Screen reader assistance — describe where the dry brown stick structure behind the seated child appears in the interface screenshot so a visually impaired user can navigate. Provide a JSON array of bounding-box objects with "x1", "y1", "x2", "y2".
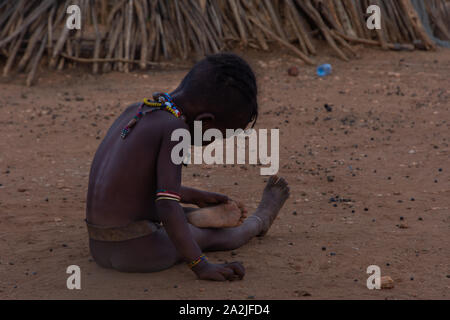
[{"x1": 0, "y1": 0, "x2": 450, "y2": 85}]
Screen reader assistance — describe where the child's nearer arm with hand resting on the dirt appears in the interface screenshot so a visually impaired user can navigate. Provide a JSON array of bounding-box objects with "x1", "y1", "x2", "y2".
[{"x1": 156, "y1": 121, "x2": 245, "y2": 281}]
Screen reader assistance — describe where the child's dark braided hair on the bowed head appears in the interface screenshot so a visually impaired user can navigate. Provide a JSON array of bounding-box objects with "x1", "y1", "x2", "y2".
[{"x1": 180, "y1": 53, "x2": 258, "y2": 126}]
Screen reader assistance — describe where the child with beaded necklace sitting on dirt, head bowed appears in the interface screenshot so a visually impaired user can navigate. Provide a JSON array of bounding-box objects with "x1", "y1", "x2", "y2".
[{"x1": 86, "y1": 53, "x2": 289, "y2": 281}]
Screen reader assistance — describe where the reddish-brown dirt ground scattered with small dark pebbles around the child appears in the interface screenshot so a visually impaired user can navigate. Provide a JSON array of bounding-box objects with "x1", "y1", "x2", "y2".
[{"x1": 0, "y1": 48, "x2": 450, "y2": 299}]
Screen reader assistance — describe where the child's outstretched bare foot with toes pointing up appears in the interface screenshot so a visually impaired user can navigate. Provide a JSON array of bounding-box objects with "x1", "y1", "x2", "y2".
[{"x1": 249, "y1": 176, "x2": 289, "y2": 237}]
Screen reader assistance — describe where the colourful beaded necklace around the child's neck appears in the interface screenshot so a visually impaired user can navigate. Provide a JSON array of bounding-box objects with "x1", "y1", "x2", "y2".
[{"x1": 120, "y1": 93, "x2": 184, "y2": 139}]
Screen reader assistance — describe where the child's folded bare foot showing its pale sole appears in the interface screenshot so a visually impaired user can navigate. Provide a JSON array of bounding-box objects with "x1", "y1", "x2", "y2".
[{"x1": 187, "y1": 201, "x2": 247, "y2": 228}]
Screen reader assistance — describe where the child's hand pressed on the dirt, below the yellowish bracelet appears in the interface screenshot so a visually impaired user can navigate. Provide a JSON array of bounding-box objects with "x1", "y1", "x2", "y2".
[{"x1": 192, "y1": 261, "x2": 245, "y2": 281}]
